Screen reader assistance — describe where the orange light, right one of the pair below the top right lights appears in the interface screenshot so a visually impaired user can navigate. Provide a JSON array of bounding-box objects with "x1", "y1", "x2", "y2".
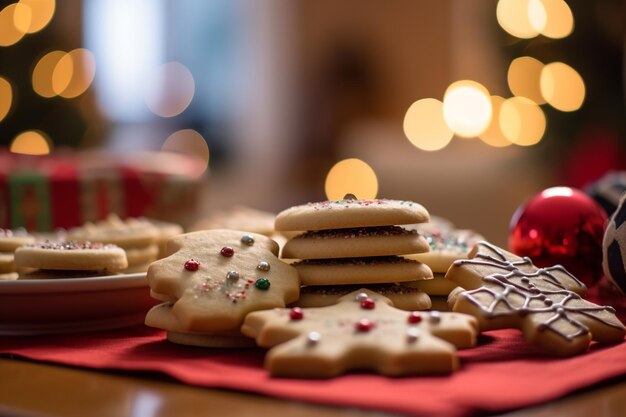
[{"x1": 540, "y1": 62, "x2": 585, "y2": 111}]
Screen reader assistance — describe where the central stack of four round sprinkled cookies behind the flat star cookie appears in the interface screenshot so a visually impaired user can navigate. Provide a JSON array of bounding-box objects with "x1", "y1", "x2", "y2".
[{"x1": 275, "y1": 195, "x2": 433, "y2": 310}]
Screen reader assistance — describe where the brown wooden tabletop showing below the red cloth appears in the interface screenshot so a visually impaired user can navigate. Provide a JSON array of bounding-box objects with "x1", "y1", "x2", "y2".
[{"x1": 0, "y1": 358, "x2": 626, "y2": 417}]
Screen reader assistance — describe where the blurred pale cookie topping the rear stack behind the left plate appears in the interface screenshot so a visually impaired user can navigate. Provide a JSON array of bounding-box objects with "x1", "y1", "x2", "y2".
[{"x1": 67, "y1": 214, "x2": 159, "y2": 249}]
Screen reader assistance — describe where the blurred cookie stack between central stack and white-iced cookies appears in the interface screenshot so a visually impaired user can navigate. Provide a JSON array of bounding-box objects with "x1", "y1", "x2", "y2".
[{"x1": 407, "y1": 218, "x2": 484, "y2": 311}]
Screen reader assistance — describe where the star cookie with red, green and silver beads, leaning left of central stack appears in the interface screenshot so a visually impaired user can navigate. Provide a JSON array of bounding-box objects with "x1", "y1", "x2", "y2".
[{"x1": 148, "y1": 229, "x2": 300, "y2": 342}]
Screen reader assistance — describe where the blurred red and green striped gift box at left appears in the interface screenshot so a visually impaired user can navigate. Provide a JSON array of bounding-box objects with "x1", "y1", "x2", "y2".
[{"x1": 0, "y1": 150, "x2": 202, "y2": 231}]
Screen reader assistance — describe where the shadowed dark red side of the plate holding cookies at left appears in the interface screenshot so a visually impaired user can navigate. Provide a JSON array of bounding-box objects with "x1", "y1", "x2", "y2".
[{"x1": 0, "y1": 273, "x2": 159, "y2": 336}]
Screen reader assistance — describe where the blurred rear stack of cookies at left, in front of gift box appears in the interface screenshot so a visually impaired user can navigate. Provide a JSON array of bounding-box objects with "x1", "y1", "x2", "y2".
[{"x1": 67, "y1": 214, "x2": 183, "y2": 273}]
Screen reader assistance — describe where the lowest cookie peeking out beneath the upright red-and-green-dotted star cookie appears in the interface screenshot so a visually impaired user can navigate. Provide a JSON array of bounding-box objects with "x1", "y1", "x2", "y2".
[{"x1": 146, "y1": 302, "x2": 256, "y2": 348}]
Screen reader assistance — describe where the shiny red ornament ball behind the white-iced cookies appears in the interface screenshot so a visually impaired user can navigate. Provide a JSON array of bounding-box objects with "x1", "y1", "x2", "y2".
[{"x1": 509, "y1": 187, "x2": 607, "y2": 287}]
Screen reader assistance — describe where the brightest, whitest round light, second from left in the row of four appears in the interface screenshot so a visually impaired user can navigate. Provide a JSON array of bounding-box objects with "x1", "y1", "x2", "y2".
[{"x1": 443, "y1": 80, "x2": 492, "y2": 137}]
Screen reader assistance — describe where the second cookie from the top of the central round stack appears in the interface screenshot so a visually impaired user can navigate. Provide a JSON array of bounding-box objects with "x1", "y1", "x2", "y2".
[{"x1": 282, "y1": 226, "x2": 429, "y2": 259}]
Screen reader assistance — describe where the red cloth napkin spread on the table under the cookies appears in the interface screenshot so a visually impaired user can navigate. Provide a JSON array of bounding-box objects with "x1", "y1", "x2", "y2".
[{"x1": 0, "y1": 320, "x2": 626, "y2": 416}]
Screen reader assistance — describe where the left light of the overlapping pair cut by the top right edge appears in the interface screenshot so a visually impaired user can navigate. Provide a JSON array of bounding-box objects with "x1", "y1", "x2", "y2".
[{"x1": 496, "y1": 0, "x2": 545, "y2": 39}]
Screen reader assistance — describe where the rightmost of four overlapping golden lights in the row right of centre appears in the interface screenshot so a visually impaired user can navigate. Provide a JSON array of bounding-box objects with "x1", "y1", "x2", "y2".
[{"x1": 499, "y1": 97, "x2": 546, "y2": 146}]
